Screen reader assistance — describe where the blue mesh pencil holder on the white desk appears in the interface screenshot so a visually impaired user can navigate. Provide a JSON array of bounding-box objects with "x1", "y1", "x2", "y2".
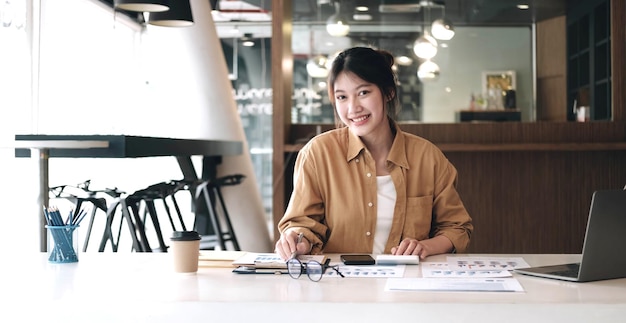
[{"x1": 46, "y1": 225, "x2": 79, "y2": 263}]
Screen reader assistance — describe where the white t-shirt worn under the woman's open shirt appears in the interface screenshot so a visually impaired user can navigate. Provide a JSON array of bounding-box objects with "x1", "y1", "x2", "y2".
[{"x1": 373, "y1": 175, "x2": 396, "y2": 255}]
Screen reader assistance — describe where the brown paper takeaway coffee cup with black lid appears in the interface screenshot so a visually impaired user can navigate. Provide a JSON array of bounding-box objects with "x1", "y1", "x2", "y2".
[{"x1": 170, "y1": 231, "x2": 200, "y2": 273}]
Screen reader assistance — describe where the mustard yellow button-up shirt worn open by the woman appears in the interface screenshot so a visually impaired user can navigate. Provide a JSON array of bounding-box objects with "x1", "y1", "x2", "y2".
[{"x1": 278, "y1": 125, "x2": 473, "y2": 254}]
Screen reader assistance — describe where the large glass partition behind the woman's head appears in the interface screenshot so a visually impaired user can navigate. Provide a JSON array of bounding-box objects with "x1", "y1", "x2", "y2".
[{"x1": 292, "y1": 25, "x2": 534, "y2": 123}]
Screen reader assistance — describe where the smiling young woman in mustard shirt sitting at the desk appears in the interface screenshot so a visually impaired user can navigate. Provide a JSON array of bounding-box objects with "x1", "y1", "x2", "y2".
[{"x1": 275, "y1": 47, "x2": 473, "y2": 259}]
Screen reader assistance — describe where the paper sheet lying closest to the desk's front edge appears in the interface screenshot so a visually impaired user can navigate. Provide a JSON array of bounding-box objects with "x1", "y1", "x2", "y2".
[{"x1": 385, "y1": 278, "x2": 524, "y2": 292}]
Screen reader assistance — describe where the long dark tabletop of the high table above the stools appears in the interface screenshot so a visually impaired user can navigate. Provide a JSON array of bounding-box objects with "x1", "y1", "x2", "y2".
[{"x1": 15, "y1": 135, "x2": 243, "y2": 158}]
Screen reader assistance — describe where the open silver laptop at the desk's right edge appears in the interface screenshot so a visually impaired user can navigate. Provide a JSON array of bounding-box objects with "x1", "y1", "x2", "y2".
[{"x1": 514, "y1": 190, "x2": 626, "y2": 282}]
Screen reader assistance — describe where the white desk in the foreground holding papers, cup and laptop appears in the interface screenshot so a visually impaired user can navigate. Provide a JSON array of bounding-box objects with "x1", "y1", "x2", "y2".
[{"x1": 0, "y1": 253, "x2": 626, "y2": 323}]
